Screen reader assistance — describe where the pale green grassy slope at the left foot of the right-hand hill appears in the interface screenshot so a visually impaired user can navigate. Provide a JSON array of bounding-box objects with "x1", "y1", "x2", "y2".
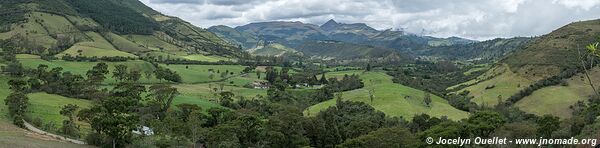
[{"x1": 458, "y1": 65, "x2": 534, "y2": 106}]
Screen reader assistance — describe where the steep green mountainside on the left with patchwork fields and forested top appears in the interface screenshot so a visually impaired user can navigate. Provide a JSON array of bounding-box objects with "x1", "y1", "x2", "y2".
[{"x1": 0, "y1": 0, "x2": 242, "y2": 57}]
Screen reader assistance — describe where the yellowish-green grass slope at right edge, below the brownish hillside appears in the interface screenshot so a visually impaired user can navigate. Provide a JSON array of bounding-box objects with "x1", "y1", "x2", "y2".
[{"x1": 516, "y1": 67, "x2": 600, "y2": 118}]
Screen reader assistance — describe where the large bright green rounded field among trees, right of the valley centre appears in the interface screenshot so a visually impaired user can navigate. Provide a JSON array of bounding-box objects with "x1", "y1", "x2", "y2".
[{"x1": 304, "y1": 71, "x2": 468, "y2": 120}]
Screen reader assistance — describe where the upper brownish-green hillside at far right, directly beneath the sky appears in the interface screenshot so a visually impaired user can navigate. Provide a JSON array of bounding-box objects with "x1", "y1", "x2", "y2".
[{"x1": 501, "y1": 20, "x2": 600, "y2": 78}]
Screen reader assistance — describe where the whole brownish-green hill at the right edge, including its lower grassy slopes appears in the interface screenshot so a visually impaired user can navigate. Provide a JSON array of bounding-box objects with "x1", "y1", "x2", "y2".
[{"x1": 452, "y1": 20, "x2": 600, "y2": 118}]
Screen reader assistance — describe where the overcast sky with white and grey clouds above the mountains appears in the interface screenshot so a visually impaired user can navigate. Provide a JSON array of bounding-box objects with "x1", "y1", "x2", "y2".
[{"x1": 141, "y1": 0, "x2": 600, "y2": 40}]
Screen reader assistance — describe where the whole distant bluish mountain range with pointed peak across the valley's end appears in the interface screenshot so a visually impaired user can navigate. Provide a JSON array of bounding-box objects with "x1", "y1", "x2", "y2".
[{"x1": 208, "y1": 19, "x2": 529, "y2": 60}]
